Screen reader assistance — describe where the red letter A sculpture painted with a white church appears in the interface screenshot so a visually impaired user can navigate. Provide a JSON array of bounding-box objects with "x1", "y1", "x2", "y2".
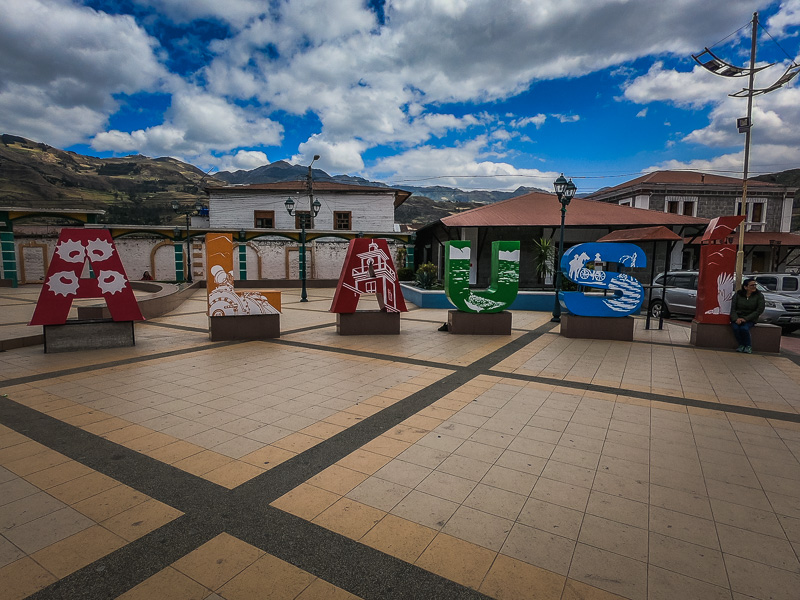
[{"x1": 331, "y1": 238, "x2": 408, "y2": 313}]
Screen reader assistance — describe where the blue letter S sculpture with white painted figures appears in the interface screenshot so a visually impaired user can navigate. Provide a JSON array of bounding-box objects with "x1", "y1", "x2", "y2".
[{"x1": 559, "y1": 242, "x2": 647, "y2": 317}]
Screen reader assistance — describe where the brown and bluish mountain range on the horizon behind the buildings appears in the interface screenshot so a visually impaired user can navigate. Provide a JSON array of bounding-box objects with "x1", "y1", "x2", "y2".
[{"x1": 0, "y1": 134, "x2": 800, "y2": 228}]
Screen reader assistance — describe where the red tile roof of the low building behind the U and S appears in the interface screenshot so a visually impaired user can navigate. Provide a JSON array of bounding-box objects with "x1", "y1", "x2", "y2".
[{"x1": 442, "y1": 192, "x2": 708, "y2": 227}]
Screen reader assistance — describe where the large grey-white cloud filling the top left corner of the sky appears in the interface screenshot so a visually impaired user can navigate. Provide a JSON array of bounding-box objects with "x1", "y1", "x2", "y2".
[{"x1": 0, "y1": 0, "x2": 171, "y2": 145}]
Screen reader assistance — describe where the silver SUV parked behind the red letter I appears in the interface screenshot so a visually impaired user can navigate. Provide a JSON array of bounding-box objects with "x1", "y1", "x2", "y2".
[{"x1": 648, "y1": 271, "x2": 800, "y2": 333}]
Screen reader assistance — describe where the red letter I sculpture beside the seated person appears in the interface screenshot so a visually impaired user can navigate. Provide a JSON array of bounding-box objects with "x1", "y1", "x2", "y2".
[{"x1": 695, "y1": 216, "x2": 744, "y2": 325}]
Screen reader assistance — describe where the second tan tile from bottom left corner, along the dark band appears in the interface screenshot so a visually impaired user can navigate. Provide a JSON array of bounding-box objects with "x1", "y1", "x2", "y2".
[{"x1": 31, "y1": 525, "x2": 127, "y2": 577}]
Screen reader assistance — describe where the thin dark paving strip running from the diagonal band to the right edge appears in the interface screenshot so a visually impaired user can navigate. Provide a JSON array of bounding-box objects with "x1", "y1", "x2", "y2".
[{"x1": 487, "y1": 371, "x2": 800, "y2": 423}]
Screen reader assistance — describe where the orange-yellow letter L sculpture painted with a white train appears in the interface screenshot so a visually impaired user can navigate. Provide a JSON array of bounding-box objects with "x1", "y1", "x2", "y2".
[{"x1": 206, "y1": 233, "x2": 281, "y2": 317}]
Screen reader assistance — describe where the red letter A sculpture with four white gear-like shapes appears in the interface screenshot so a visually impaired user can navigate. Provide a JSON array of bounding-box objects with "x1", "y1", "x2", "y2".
[{"x1": 29, "y1": 229, "x2": 144, "y2": 325}]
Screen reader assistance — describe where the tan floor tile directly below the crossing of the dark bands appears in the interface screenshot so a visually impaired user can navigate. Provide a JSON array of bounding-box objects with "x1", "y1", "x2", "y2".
[{"x1": 172, "y1": 533, "x2": 264, "y2": 590}]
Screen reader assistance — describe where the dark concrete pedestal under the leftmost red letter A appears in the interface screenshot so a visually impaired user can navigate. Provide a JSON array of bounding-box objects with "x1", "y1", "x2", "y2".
[{"x1": 42, "y1": 319, "x2": 136, "y2": 353}]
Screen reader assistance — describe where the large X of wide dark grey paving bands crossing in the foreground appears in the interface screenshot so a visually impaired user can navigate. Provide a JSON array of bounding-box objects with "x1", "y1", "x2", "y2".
[{"x1": 0, "y1": 326, "x2": 552, "y2": 600}]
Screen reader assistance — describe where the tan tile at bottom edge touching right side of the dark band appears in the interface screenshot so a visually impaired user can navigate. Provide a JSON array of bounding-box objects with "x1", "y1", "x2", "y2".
[{"x1": 480, "y1": 554, "x2": 565, "y2": 600}]
